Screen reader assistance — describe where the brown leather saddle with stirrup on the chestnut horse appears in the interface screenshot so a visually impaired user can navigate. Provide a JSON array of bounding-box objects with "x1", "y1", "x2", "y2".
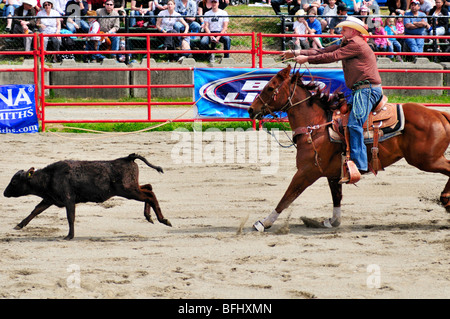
[{"x1": 328, "y1": 95, "x2": 405, "y2": 184}]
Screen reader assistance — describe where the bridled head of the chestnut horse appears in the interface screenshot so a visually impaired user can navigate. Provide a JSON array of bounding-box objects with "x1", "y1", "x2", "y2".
[{"x1": 248, "y1": 65, "x2": 291, "y2": 119}]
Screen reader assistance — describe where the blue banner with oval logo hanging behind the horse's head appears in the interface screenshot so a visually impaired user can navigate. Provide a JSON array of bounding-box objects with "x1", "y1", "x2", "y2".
[{"x1": 194, "y1": 68, "x2": 351, "y2": 118}]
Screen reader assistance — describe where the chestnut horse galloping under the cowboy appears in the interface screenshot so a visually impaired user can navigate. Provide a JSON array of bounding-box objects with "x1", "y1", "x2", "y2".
[{"x1": 248, "y1": 65, "x2": 450, "y2": 231}]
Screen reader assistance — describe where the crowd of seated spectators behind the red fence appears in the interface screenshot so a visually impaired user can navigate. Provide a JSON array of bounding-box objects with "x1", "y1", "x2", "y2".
[{"x1": 0, "y1": 0, "x2": 450, "y2": 63}]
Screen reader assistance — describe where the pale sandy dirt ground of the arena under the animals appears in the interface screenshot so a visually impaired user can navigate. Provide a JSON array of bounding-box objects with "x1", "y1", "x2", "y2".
[{"x1": 0, "y1": 125, "x2": 450, "y2": 299}]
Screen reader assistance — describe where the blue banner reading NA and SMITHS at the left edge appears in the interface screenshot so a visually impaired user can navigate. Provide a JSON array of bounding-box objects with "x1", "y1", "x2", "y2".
[{"x1": 0, "y1": 84, "x2": 39, "y2": 133}]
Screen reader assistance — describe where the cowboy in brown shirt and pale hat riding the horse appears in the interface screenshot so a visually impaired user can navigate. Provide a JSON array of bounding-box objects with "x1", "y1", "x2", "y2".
[{"x1": 281, "y1": 16, "x2": 383, "y2": 183}]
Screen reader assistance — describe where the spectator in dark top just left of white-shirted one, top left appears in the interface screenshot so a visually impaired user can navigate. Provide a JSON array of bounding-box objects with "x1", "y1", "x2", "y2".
[{"x1": 11, "y1": 0, "x2": 37, "y2": 51}]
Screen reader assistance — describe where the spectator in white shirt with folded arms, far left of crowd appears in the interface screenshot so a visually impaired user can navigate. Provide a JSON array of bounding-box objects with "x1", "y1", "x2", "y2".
[{"x1": 36, "y1": 0, "x2": 61, "y2": 63}]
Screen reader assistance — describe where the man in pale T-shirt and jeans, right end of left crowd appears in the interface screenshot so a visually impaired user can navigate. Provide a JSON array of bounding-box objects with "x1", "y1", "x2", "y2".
[{"x1": 200, "y1": 0, "x2": 229, "y2": 63}]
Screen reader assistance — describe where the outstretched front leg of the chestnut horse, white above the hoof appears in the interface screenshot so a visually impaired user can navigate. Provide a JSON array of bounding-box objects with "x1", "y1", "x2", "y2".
[{"x1": 253, "y1": 170, "x2": 320, "y2": 232}]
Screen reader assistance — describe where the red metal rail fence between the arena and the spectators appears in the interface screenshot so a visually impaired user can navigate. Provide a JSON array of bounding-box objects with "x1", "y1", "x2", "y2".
[{"x1": 0, "y1": 33, "x2": 450, "y2": 131}]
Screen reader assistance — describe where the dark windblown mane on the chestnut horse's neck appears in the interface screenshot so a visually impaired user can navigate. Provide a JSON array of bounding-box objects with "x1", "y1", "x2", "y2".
[{"x1": 292, "y1": 71, "x2": 344, "y2": 111}]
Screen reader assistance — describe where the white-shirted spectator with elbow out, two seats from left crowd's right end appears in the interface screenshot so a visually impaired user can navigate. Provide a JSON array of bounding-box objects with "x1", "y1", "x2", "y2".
[{"x1": 156, "y1": 0, "x2": 191, "y2": 62}]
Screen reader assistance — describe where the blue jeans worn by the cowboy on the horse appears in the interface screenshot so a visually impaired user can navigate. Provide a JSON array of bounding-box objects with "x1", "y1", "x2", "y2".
[{"x1": 348, "y1": 87, "x2": 383, "y2": 171}]
